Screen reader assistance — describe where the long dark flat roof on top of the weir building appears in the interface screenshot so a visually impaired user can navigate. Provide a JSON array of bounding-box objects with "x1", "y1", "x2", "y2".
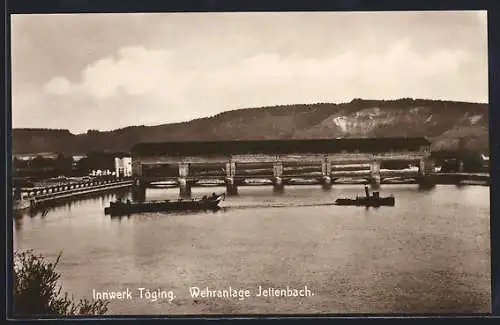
[{"x1": 131, "y1": 138, "x2": 430, "y2": 156}]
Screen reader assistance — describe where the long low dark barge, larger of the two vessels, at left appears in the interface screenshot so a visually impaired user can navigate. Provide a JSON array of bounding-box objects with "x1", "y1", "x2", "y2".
[{"x1": 104, "y1": 193, "x2": 226, "y2": 216}]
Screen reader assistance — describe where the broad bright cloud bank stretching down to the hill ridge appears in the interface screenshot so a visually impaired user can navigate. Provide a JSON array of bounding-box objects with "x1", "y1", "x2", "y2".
[{"x1": 27, "y1": 39, "x2": 488, "y2": 130}]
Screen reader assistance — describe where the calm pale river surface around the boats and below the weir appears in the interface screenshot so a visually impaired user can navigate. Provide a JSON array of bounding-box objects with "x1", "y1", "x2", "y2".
[{"x1": 14, "y1": 185, "x2": 491, "y2": 315}]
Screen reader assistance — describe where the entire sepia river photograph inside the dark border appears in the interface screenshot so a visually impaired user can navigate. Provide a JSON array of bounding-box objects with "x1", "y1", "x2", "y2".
[{"x1": 10, "y1": 11, "x2": 491, "y2": 317}]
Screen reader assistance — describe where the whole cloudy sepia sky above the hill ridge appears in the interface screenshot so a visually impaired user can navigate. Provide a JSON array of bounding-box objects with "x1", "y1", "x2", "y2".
[{"x1": 11, "y1": 11, "x2": 488, "y2": 134}]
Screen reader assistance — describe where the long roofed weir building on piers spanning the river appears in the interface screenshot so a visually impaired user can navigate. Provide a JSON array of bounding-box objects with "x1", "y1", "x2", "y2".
[{"x1": 131, "y1": 137, "x2": 434, "y2": 196}]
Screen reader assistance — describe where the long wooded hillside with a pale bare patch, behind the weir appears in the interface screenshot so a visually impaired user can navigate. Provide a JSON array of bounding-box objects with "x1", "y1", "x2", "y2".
[{"x1": 12, "y1": 99, "x2": 488, "y2": 155}]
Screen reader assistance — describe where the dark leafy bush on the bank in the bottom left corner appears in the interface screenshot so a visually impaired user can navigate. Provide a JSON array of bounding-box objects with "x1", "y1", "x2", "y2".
[{"x1": 13, "y1": 250, "x2": 109, "y2": 317}]
